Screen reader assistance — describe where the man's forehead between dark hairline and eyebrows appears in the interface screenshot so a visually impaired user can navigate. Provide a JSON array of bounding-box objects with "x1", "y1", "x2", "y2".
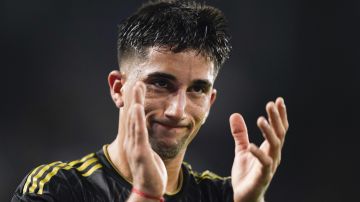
[{"x1": 135, "y1": 48, "x2": 215, "y2": 83}]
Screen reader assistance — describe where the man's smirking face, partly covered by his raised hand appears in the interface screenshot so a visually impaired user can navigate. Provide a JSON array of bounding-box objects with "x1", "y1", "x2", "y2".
[{"x1": 123, "y1": 48, "x2": 216, "y2": 159}]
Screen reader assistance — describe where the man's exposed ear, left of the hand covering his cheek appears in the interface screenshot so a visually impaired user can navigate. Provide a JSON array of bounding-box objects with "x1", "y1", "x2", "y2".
[{"x1": 108, "y1": 70, "x2": 125, "y2": 108}]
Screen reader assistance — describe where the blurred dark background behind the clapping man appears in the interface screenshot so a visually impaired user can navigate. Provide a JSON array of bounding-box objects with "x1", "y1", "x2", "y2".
[{"x1": 0, "y1": 0, "x2": 360, "y2": 202}]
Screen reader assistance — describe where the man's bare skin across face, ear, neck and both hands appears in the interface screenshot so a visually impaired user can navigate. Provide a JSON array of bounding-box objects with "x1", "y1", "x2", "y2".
[{"x1": 108, "y1": 48, "x2": 288, "y2": 202}]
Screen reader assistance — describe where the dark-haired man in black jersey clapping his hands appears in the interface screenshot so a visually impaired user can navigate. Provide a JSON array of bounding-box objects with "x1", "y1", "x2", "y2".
[{"x1": 12, "y1": 0, "x2": 288, "y2": 202}]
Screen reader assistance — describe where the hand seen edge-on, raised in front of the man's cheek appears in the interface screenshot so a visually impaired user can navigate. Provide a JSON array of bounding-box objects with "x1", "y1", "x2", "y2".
[{"x1": 122, "y1": 82, "x2": 167, "y2": 197}]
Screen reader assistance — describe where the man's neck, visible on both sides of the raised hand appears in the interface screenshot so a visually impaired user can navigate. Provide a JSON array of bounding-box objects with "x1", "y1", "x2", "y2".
[{"x1": 108, "y1": 131, "x2": 185, "y2": 195}]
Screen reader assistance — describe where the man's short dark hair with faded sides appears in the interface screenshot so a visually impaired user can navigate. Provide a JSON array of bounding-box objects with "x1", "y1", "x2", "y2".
[{"x1": 117, "y1": 0, "x2": 231, "y2": 75}]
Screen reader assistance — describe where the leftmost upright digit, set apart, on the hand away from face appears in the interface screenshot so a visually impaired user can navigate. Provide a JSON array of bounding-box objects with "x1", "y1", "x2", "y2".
[{"x1": 229, "y1": 113, "x2": 249, "y2": 151}]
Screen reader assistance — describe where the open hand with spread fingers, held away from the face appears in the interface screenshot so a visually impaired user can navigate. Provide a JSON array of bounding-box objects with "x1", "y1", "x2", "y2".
[{"x1": 230, "y1": 98, "x2": 289, "y2": 202}]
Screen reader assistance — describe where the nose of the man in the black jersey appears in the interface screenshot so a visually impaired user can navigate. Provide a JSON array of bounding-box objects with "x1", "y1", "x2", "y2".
[{"x1": 165, "y1": 91, "x2": 186, "y2": 121}]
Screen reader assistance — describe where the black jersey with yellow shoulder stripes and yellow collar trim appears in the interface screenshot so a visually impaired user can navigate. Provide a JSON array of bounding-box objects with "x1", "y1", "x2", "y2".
[{"x1": 11, "y1": 146, "x2": 233, "y2": 202}]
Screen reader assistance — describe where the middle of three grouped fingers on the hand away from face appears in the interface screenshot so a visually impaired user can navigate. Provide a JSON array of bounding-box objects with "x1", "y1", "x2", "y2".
[{"x1": 266, "y1": 102, "x2": 285, "y2": 143}]
